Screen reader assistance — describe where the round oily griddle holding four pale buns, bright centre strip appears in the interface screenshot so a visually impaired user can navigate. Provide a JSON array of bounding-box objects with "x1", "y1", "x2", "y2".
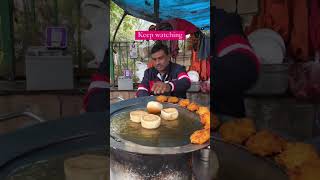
[{"x1": 110, "y1": 96, "x2": 209, "y2": 155}]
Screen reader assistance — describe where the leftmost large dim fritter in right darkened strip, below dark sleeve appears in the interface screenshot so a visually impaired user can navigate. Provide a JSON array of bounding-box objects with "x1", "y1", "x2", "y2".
[{"x1": 219, "y1": 118, "x2": 256, "y2": 144}]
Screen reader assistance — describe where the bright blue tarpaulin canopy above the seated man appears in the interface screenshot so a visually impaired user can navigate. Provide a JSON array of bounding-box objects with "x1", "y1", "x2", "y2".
[{"x1": 113, "y1": 0, "x2": 210, "y2": 29}]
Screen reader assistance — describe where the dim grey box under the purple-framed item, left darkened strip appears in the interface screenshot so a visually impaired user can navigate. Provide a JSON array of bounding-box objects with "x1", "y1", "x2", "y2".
[{"x1": 26, "y1": 47, "x2": 74, "y2": 90}]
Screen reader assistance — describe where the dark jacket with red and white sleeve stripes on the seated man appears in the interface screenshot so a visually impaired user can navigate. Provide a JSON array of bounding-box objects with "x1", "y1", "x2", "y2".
[{"x1": 136, "y1": 62, "x2": 191, "y2": 98}]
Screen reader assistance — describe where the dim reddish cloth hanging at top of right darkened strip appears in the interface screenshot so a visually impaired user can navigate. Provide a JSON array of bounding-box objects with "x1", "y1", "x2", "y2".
[{"x1": 246, "y1": 0, "x2": 310, "y2": 61}]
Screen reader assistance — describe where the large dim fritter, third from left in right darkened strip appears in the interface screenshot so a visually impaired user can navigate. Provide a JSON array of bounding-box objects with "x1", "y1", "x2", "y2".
[{"x1": 275, "y1": 143, "x2": 319, "y2": 170}]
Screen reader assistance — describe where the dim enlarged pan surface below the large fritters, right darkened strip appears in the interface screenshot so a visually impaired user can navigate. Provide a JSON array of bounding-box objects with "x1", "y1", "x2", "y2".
[{"x1": 211, "y1": 135, "x2": 288, "y2": 180}]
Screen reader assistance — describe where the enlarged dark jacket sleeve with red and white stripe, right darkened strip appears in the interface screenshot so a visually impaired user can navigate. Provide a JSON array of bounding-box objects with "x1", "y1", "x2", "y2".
[{"x1": 211, "y1": 7, "x2": 260, "y2": 117}]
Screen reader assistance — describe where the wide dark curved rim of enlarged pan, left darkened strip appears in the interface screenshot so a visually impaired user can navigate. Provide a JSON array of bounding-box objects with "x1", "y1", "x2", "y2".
[{"x1": 0, "y1": 113, "x2": 109, "y2": 180}]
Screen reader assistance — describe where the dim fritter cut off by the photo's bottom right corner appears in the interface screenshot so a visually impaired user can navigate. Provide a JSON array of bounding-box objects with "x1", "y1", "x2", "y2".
[{"x1": 288, "y1": 159, "x2": 320, "y2": 180}]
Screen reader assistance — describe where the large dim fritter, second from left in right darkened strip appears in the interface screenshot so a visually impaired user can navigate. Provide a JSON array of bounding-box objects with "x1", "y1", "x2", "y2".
[{"x1": 246, "y1": 130, "x2": 286, "y2": 156}]
